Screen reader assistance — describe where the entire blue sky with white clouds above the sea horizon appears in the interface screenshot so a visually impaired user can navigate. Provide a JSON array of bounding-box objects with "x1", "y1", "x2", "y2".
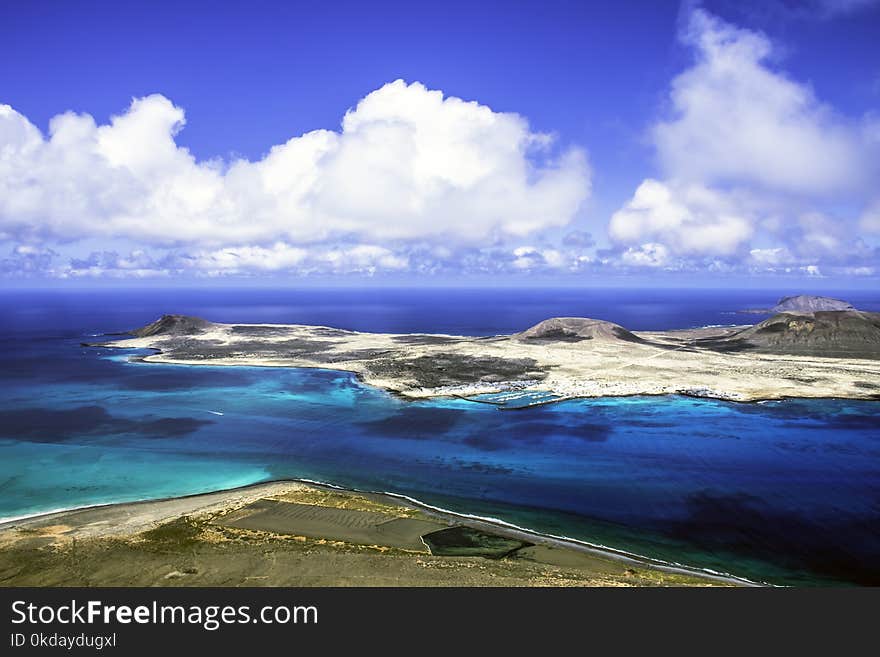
[{"x1": 0, "y1": 0, "x2": 880, "y2": 288}]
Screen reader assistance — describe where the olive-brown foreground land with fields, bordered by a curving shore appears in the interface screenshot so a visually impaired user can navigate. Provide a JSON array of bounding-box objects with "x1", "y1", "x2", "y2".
[{"x1": 0, "y1": 481, "x2": 743, "y2": 586}]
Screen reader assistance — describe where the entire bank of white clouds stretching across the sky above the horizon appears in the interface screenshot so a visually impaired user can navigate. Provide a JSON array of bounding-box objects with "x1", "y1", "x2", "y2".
[{"x1": 0, "y1": 10, "x2": 880, "y2": 278}]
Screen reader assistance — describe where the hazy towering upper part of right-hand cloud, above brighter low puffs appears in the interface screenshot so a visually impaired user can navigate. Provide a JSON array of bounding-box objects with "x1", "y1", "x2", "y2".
[{"x1": 652, "y1": 10, "x2": 876, "y2": 195}]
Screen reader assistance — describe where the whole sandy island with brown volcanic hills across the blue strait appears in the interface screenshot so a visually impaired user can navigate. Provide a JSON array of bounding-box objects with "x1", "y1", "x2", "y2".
[{"x1": 91, "y1": 300, "x2": 880, "y2": 400}]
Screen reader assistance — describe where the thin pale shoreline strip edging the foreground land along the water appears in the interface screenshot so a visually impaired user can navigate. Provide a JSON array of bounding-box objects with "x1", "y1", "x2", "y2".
[{"x1": 0, "y1": 477, "x2": 756, "y2": 587}]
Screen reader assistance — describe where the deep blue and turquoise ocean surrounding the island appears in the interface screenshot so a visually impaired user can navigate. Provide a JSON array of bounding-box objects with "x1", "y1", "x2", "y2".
[{"x1": 0, "y1": 289, "x2": 880, "y2": 585}]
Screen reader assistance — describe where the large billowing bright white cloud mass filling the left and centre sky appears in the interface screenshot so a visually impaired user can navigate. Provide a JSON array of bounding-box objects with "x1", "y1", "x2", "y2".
[{"x1": 0, "y1": 80, "x2": 590, "y2": 254}]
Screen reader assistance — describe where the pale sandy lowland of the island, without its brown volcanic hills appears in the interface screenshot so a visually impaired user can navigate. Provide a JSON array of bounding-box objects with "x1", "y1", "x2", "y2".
[{"x1": 104, "y1": 320, "x2": 880, "y2": 401}]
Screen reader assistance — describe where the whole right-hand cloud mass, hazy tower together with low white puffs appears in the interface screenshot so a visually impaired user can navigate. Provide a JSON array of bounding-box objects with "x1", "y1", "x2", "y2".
[{"x1": 609, "y1": 9, "x2": 880, "y2": 275}]
